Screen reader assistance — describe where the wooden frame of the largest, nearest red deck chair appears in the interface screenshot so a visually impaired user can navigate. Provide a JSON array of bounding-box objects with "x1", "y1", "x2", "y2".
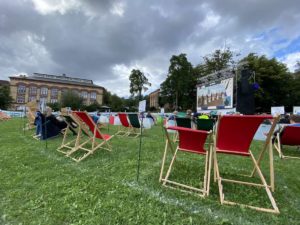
[{"x1": 213, "y1": 116, "x2": 280, "y2": 214}]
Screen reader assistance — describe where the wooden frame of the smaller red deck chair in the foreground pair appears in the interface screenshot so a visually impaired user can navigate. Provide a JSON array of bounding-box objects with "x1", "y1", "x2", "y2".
[{"x1": 159, "y1": 127, "x2": 212, "y2": 197}]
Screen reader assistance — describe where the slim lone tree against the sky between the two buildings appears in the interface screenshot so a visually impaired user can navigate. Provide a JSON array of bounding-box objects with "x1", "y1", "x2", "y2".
[{"x1": 129, "y1": 69, "x2": 151, "y2": 100}]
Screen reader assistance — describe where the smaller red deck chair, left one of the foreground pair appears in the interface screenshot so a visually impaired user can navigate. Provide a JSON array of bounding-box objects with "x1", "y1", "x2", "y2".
[{"x1": 159, "y1": 126, "x2": 212, "y2": 197}]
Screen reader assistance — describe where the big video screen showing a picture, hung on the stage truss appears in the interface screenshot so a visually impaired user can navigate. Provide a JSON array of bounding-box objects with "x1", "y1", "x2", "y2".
[{"x1": 197, "y1": 78, "x2": 233, "y2": 111}]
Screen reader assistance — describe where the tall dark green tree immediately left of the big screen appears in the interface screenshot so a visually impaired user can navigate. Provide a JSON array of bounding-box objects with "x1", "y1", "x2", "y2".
[{"x1": 161, "y1": 54, "x2": 197, "y2": 109}]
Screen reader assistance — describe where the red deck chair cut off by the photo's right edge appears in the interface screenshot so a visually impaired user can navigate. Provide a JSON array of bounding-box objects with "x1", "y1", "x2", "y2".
[{"x1": 274, "y1": 126, "x2": 300, "y2": 159}]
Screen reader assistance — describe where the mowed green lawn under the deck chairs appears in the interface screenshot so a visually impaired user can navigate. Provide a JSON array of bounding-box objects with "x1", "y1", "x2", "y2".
[{"x1": 0, "y1": 119, "x2": 300, "y2": 225}]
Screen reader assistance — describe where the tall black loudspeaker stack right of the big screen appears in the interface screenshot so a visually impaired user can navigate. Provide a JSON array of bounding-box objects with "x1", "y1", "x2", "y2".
[{"x1": 236, "y1": 69, "x2": 255, "y2": 115}]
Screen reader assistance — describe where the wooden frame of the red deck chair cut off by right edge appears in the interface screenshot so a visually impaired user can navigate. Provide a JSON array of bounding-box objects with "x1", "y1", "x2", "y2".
[{"x1": 274, "y1": 126, "x2": 300, "y2": 159}]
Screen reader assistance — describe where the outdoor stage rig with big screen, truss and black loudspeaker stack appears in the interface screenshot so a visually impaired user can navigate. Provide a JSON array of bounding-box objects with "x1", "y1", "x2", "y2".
[{"x1": 196, "y1": 63, "x2": 255, "y2": 115}]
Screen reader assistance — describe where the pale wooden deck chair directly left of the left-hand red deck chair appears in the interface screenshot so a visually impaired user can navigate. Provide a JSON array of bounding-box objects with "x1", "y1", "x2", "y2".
[{"x1": 57, "y1": 113, "x2": 91, "y2": 154}]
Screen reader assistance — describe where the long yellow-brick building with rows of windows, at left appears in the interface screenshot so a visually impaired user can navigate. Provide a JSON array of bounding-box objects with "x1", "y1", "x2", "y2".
[{"x1": 9, "y1": 73, "x2": 104, "y2": 108}]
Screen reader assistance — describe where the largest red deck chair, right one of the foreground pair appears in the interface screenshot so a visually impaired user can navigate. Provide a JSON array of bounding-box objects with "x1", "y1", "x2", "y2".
[{"x1": 214, "y1": 115, "x2": 279, "y2": 213}]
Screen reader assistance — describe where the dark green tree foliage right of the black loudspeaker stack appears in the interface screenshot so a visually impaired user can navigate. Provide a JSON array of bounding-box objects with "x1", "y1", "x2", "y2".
[{"x1": 241, "y1": 53, "x2": 299, "y2": 112}]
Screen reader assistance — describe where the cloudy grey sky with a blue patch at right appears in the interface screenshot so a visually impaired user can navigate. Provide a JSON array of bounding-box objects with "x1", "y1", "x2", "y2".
[{"x1": 0, "y1": 0, "x2": 300, "y2": 96}]
